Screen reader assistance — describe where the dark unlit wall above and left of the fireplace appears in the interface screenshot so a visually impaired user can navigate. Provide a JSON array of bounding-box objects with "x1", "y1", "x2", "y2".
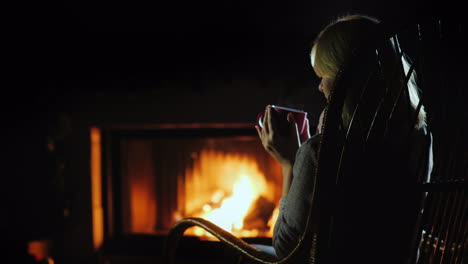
[{"x1": 1, "y1": 0, "x2": 460, "y2": 263}]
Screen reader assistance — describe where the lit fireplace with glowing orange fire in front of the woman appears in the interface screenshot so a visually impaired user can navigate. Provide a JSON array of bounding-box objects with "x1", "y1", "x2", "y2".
[{"x1": 91, "y1": 124, "x2": 281, "y2": 248}]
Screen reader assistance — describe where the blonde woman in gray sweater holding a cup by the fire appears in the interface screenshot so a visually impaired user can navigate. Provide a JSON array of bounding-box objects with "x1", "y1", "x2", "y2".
[{"x1": 256, "y1": 15, "x2": 431, "y2": 260}]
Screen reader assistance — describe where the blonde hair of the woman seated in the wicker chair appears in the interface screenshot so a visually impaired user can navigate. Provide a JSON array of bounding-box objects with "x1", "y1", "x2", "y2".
[{"x1": 310, "y1": 14, "x2": 426, "y2": 128}]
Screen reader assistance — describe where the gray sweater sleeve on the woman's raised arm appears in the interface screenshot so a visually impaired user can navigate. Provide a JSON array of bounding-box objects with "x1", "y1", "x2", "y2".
[{"x1": 273, "y1": 135, "x2": 321, "y2": 257}]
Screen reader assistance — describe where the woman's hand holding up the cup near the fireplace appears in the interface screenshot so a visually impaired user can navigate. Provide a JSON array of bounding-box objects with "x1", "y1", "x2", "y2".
[{"x1": 255, "y1": 106, "x2": 301, "y2": 168}]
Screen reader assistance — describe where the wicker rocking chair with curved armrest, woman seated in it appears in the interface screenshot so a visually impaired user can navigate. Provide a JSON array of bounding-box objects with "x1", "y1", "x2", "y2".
[{"x1": 165, "y1": 20, "x2": 468, "y2": 264}]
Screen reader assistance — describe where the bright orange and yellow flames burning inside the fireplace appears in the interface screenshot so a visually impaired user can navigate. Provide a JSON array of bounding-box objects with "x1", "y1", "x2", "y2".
[{"x1": 180, "y1": 150, "x2": 277, "y2": 238}]
